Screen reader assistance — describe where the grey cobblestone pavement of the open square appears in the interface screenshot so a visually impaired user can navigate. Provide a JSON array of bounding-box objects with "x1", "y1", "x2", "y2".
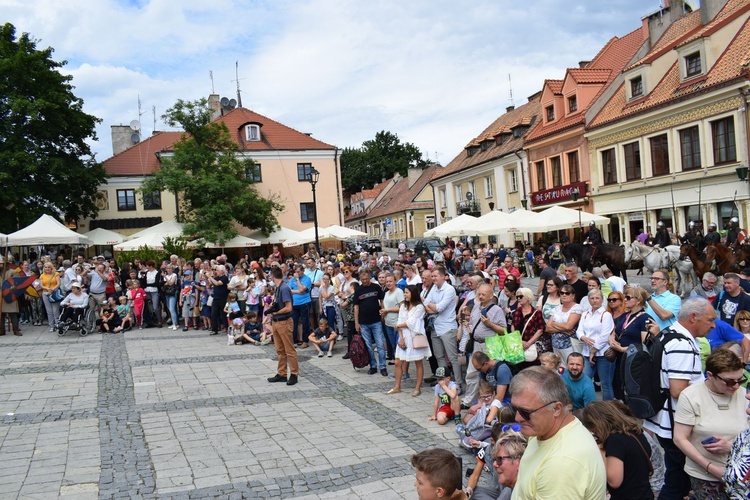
[{"x1": 0, "y1": 272, "x2": 652, "y2": 499}]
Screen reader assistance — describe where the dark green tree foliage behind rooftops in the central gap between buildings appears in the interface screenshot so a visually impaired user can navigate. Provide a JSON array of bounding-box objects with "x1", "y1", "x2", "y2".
[{"x1": 341, "y1": 130, "x2": 428, "y2": 192}]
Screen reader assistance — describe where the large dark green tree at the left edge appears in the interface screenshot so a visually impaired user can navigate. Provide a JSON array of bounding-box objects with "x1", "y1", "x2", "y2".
[{"x1": 0, "y1": 23, "x2": 107, "y2": 233}]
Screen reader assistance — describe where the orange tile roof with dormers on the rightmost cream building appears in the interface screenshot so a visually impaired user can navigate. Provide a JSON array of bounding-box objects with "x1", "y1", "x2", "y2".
[{"x1": 588, "y1": 5, "x2": 750, "y2": 129}]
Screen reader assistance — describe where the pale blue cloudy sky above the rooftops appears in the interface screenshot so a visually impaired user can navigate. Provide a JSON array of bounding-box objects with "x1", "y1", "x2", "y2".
[{"x1": 0, "y1": 0, "x2": 698, "y2": 165}]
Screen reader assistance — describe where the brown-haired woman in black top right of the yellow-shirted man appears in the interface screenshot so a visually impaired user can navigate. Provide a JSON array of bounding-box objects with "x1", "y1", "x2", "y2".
[{"x1": 581, "y1": 400, "x2": 654, "y2": 500}]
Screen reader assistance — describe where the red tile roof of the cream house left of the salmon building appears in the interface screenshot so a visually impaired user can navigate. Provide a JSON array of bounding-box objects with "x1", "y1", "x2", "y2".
[{"x1": 432, "y1": 92, "x2": 541, "y2": 180}]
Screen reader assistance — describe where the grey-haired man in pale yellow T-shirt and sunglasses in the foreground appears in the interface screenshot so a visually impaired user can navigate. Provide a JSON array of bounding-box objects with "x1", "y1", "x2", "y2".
[{"x1": 510, "y1": 366, "x2": 607, "y2": 500}]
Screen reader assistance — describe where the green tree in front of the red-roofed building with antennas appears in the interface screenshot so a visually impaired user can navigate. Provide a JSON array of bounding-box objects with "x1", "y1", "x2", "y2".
[{"x1": 139, "y1": 99, "x2": 284, "y2": 244}]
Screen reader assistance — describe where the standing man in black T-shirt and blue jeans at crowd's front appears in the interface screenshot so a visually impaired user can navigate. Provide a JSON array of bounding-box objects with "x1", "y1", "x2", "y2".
[{"x1": 353, "y1": 270, "x2": 388, "y2": 377}]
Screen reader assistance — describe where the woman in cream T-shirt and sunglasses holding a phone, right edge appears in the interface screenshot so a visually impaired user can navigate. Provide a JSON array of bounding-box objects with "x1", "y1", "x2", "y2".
[{"x1": 674, "y1": 349, "x2": 748, "y2": 500}]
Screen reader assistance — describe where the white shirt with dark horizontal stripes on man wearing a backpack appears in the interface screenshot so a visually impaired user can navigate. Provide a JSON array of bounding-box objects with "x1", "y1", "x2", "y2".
[{"x1": 643, "y1": 322, "x2": 704, "y2": 439}]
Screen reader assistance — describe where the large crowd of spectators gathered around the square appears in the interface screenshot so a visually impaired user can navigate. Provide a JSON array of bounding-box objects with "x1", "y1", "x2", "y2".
[{"x1": 3, "y1": 242, "x2": 750, "y2": 499}]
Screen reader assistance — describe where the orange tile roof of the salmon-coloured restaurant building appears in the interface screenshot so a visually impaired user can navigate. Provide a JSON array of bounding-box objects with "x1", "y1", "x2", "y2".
[{"x1": 526, "y1": 28, "x2": 644, "y2": 143}]
